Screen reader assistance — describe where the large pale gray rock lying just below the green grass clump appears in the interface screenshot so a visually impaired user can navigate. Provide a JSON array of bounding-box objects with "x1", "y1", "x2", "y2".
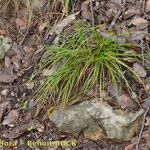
[{"x1": 50, "y1": 100, "x2": 143, "y2": 141}]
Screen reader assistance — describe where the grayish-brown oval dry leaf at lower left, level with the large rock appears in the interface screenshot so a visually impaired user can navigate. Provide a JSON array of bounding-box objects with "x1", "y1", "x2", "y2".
[{"x1": 2, "y1": 110, "x2": 19, "y2": 125}]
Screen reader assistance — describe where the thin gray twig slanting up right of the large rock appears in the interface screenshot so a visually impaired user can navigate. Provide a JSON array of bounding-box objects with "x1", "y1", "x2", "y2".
[{"x1": 136, "y1": 107, "x2": 150, "y2": 150}]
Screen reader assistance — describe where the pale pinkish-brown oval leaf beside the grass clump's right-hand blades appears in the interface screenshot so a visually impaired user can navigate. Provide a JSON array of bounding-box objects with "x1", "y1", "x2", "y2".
[{"x1": 133, "y1": 63, "x2": 147, "y2": 78}]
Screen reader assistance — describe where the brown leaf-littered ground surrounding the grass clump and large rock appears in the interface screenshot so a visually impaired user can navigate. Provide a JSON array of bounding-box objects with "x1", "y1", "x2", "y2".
[{"x1": 0, "y1": 0, "x2": 150, "y2": 150}]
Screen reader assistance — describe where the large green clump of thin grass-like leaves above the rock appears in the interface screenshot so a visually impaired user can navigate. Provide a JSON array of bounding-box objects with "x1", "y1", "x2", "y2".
[{"x1": 35, "y1": 23, "x2": 144, "y2": 107}]
